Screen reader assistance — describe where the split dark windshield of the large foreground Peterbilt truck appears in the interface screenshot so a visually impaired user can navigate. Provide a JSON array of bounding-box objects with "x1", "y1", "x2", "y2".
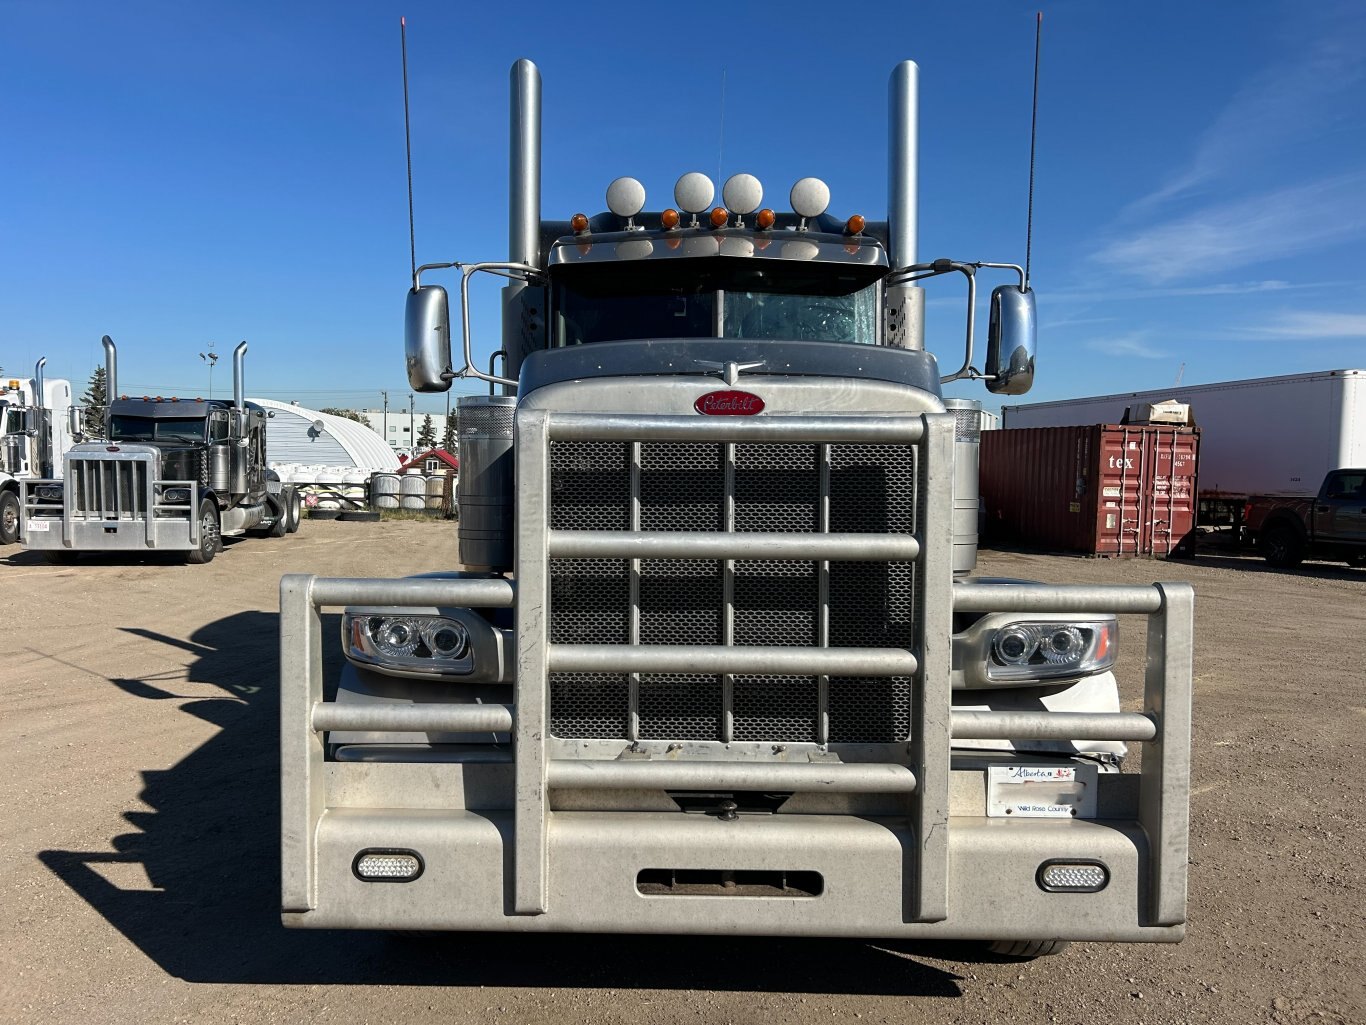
[{"x1": 555, "y1": 284, "x2": 877, "y2": 346}]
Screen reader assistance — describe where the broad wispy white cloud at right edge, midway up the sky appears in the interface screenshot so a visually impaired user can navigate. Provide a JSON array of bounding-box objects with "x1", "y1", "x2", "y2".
[{"x1": 1094, "y1": 172, "x2": 1366, "y2": 283}]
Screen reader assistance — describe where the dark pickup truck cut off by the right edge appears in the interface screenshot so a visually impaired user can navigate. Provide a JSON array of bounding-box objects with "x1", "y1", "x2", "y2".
[{"x1": 1243, "y1": 469, "x2": 1366, "y2": 567}]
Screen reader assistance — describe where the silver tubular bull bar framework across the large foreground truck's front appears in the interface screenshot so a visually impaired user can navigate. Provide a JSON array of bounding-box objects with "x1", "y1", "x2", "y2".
[{"x1": 280, "y1": 410, "x2": 1194, "y2": 925}]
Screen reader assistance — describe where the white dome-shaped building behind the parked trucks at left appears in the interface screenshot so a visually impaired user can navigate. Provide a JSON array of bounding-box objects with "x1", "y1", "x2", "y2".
[{"x1": 247, "y1": 398, "x2": 399, "y2": 481}]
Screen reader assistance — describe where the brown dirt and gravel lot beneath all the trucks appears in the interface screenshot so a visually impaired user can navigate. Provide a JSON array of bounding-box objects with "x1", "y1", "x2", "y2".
[{"x1": 0, "y1": 522, "x2": 1366, "y2": 1025}]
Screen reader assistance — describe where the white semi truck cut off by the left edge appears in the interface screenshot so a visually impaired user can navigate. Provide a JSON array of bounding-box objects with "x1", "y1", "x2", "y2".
[{"x1": 0, "y1": 357, "x2": 81, "y2": 545}]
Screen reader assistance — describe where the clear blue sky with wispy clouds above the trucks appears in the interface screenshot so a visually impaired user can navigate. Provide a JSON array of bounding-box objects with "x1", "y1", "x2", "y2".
[{"x1": 0, "y1": 0, "x2": 1366, "y2": 411}]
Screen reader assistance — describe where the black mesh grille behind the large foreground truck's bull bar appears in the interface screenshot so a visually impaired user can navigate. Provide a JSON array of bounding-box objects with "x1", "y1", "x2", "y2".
[{"x1": 548, "y1": 441, "x2": 917, "y2": 743}]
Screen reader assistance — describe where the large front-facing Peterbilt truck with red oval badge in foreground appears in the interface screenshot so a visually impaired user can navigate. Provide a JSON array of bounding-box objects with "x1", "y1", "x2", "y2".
[{"x1": 280, "y1": 60, "x2": 1193, "y2": 957}]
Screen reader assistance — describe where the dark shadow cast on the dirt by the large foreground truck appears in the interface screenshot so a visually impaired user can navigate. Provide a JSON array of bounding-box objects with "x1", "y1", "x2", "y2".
[{"x1": 40, "y1": 612, "x2": 972, "y2": 996}]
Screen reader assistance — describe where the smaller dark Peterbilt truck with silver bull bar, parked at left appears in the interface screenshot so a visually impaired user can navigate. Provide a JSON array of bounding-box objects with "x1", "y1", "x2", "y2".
[{"x1": 20, "y1": 335, "x2": 301, "y2": 563}]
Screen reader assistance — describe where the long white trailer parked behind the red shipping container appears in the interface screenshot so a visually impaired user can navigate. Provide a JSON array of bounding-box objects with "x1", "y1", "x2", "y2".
[{"x1": 1001, "y1": 370, "x2": 1366, "y2": 502}]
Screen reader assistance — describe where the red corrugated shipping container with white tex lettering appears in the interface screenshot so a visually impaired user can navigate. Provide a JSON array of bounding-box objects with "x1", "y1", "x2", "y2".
[{"x1": 981, "y1": 424, "x2": 1199, "y2": 558}]
